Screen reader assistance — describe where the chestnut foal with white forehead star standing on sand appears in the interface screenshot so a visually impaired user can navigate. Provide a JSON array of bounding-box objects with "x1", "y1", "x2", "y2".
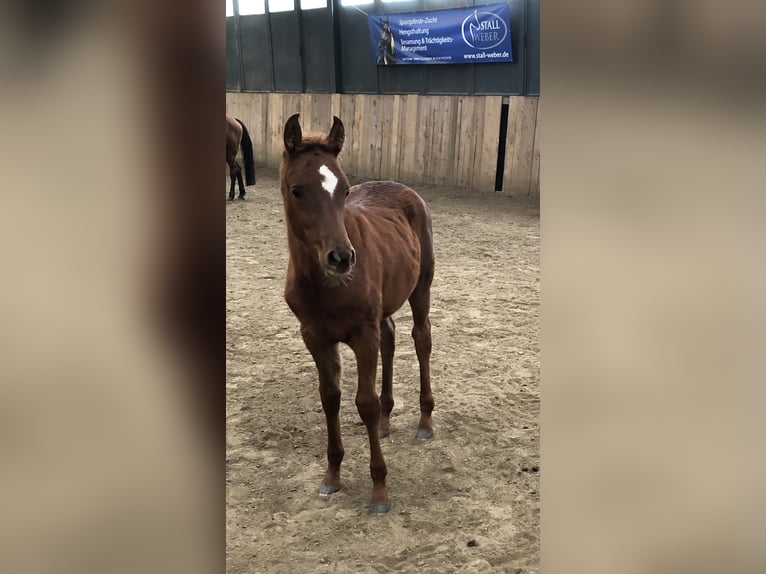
[{"x1": 280, "y1": 114, "x2": 434, "y2": 514}]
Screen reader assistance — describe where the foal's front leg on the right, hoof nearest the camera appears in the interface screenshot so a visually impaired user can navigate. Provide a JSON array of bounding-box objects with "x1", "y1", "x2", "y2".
[{"x1": 349, "y1": 324, "x2": 389, "y2": 514}]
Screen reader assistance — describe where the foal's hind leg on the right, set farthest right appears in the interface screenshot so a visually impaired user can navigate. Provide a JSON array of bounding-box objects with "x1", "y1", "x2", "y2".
[{"x1": 410, "y1": 282, "x2": 434, "y2": 440}]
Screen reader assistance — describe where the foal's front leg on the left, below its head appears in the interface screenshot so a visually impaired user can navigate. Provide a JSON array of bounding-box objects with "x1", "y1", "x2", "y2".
[{"x1": 302, "y1": 331, "x2": 344, "y2": 496}]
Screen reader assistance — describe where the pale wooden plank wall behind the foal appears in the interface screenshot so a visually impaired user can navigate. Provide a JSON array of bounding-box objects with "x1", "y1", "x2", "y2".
[{"x1": 226, "y1": 92, "x2": 540, "y2": 195}]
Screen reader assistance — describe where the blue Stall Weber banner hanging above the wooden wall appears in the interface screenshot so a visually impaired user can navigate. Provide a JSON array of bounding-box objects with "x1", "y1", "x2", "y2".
[{"x1": 367, "y1": 4, "x2": 513, "y2": 66}]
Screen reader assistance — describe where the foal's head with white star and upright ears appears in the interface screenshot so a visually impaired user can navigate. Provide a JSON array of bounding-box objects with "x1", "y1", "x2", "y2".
[{"x1": 281, "y1": 114, "x2": 356, "y2": 278}]
